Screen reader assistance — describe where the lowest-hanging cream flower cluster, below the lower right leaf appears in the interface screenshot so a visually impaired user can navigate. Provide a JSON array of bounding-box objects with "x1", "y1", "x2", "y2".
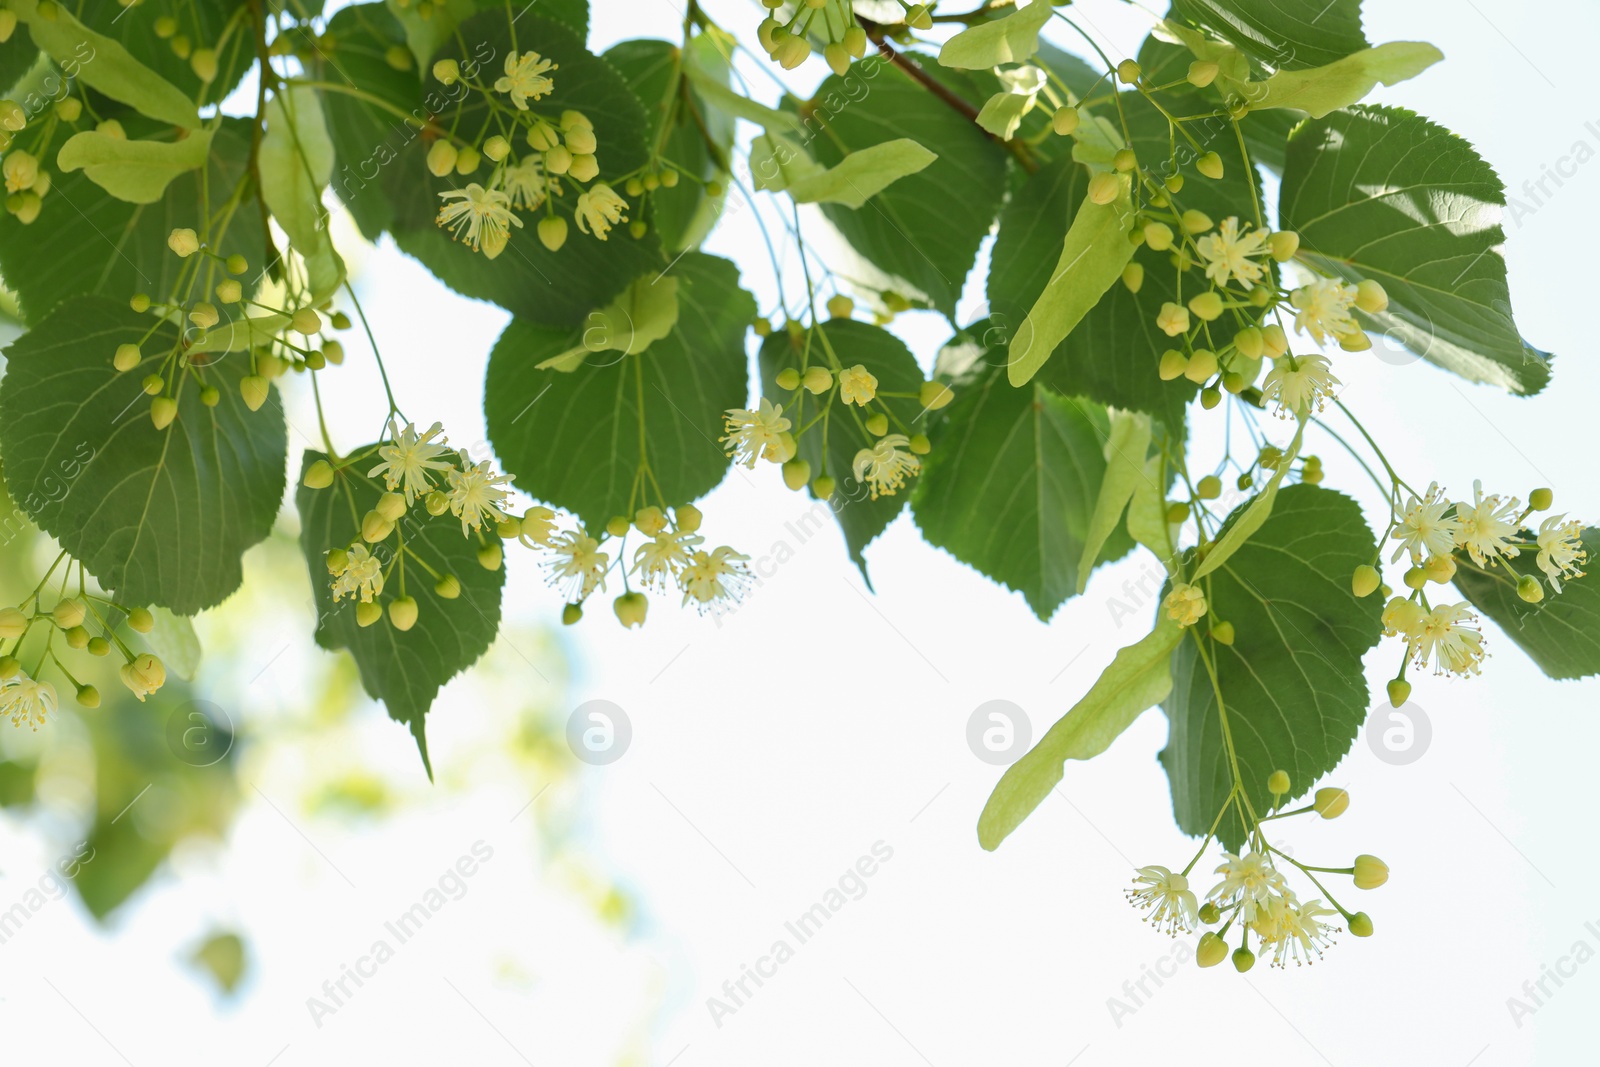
[{"x1": 1125, "y1": 771, "x2": 1389, "y2": 971}]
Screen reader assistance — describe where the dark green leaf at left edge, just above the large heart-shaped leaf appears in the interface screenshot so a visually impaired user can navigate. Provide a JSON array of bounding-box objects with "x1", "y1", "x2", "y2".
[{"x1": 0, "y1": 114, "x2": 264, "y2": 323}]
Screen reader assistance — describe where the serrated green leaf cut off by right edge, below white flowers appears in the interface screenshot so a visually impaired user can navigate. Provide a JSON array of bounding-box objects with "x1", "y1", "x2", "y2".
[{"x1": 1456, "y1": 526, "x2": 1600, "y2": 678}]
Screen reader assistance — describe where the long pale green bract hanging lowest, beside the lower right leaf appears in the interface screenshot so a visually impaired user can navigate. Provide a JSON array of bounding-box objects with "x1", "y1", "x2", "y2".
[{"x1": 978, "y1": 616, "x2": 1184, "y2": 851}]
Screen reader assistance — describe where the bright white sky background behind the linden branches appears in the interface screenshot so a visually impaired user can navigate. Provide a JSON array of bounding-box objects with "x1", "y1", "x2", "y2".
[{"x1": 0, "y1": 0, "x2": 1600, "y2": 1067}]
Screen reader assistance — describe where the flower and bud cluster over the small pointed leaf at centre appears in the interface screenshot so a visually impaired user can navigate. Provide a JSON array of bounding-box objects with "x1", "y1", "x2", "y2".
[{"x1": 732, "y1": 307, "x2": 955, "y2": 501}]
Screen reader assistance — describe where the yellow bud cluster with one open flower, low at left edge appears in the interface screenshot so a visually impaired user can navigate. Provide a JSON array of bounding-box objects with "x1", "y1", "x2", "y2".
[{"x1": 0, "y1": 579, "x2": 166, "y2": 729}]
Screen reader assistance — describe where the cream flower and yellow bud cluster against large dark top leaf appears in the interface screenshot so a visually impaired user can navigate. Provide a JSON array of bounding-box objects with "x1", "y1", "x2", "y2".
[{"x1": 424, "y1": 50, "x2": 643, "y2": 259}]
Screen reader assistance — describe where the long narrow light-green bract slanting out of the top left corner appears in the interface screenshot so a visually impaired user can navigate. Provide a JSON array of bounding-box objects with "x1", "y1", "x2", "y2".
[{"x1": 8, "y1": 0, "x2": 200, "y2": 130}]
